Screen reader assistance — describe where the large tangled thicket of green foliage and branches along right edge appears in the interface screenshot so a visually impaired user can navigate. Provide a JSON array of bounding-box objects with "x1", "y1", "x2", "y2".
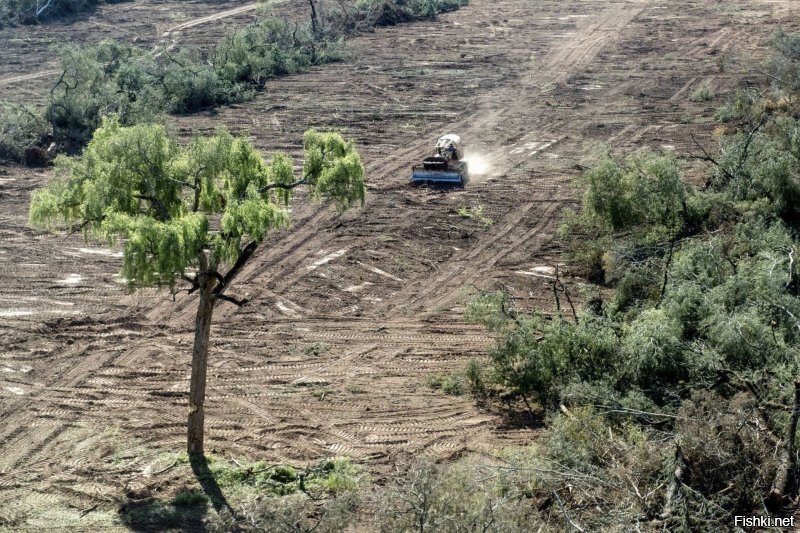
[{"x1": 468, "y1": 35, "x2": 800, "y2": 530}]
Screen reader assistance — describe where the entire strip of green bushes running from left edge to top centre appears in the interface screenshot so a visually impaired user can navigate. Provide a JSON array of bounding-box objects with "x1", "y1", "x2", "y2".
[{"x1": 0, "y1": 0, "x2": 466, "y2": 162}]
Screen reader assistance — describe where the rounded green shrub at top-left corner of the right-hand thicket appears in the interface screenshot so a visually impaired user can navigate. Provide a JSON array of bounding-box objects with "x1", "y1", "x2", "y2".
[{"x1": 560, "y1": 150, "x2": 688, "y2": 284}]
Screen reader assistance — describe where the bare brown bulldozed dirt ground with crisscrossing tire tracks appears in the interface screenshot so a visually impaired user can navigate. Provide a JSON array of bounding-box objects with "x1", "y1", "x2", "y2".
[{"x1": 0, "y1": 0, "x2": 797, "y2": 530}]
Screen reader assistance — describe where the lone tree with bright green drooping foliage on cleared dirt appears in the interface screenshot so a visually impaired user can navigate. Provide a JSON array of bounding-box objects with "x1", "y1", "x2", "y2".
[{"x1": 30, "y1": 118, "x2": 366, "y2": 456}]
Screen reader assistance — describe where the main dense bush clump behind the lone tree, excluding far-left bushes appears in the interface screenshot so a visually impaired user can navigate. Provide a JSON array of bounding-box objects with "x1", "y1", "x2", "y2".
[{"x1": 42, "y1": 23, "x2": 337, "y2": 147}]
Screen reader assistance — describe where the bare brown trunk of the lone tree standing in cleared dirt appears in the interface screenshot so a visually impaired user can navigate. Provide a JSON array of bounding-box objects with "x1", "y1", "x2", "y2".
[{"x1": 186, "y1": 252, "x2": 215, "y2": 456}]
